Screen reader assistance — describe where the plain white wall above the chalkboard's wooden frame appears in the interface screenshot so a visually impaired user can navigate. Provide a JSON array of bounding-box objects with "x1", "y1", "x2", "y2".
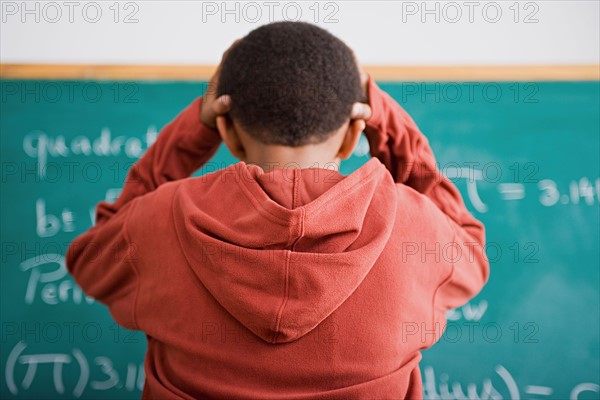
[{"x1": 0, "y1": 0, "x2": 600, "y2": 65}]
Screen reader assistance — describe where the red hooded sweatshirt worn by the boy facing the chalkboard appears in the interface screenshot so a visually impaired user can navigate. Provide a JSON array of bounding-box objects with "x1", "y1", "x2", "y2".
[{"x1": 67, "y1": 79, "x2": 489, "y2": 399}]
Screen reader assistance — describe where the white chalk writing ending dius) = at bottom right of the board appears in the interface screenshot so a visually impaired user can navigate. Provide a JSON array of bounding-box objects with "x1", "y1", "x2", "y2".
[{"x1": 422, "y1": 364, "x2": 600, "y2": 400}]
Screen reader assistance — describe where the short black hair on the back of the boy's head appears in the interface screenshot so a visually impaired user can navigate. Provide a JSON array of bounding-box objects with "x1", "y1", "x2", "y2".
[{"x1": 217, "y1": 21, "x2": 362, "y2": 147}]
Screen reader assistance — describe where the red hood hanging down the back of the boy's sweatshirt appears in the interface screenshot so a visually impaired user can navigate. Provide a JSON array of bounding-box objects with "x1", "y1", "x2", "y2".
[{"x1": 173, "y1": 158, "x2": 397, "y2": 343}]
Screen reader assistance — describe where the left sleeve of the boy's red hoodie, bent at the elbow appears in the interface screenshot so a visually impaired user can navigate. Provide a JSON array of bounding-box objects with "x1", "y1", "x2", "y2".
[{"x1": 66, "y1": 98, "x2": 221, "y2": 329}]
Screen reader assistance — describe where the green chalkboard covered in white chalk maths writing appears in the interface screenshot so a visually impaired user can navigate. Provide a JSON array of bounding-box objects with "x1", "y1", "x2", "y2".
[{"x1": 0, "y1": 80, "x2": 600, "y2": 399}]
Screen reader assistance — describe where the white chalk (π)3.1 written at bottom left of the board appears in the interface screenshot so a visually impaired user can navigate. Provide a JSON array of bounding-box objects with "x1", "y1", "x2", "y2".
[{"x1": 4, "y1": 341, "x2": 146, "y2": 398}]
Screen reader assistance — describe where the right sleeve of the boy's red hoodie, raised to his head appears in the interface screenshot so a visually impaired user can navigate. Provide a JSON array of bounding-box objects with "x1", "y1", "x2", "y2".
[{"x1": 365, "y1": 77, "x2": 489, "y2": 309}]
